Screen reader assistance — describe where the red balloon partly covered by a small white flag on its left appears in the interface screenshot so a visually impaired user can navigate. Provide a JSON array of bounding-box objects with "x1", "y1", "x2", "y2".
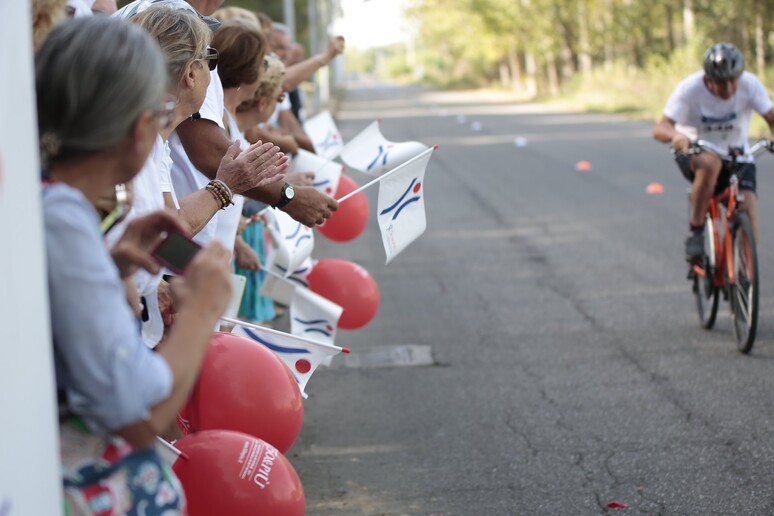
[{"x1": 307, "y1": 258, "x2": 379, "y2": 330}]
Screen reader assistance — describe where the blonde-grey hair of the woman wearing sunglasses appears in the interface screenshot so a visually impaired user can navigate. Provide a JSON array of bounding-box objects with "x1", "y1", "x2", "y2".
[{"x1": 131, "y1": 4, "x2": 212, "y2": 89}]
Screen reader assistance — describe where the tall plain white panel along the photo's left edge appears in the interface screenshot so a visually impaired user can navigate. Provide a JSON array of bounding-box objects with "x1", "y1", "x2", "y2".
[{"x1": 0, "y1": 1, "x2": 62, "y2": 516}]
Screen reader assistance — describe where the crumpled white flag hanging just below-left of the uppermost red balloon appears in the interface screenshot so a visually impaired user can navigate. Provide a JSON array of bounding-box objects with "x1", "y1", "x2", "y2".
[{"x1": 264, "y1": 210, "x2": 314, "y2": 277}]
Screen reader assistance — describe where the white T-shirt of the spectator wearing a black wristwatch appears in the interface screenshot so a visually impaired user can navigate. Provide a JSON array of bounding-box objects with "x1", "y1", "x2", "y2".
[{"x1": 169, "y1": 69, "x2": 226, "y2": 246}]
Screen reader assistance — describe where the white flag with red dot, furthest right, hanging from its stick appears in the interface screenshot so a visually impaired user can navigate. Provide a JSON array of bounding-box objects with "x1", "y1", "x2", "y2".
[{"x1": 376, "y1": 148, "x2": 434, "y2": 263}]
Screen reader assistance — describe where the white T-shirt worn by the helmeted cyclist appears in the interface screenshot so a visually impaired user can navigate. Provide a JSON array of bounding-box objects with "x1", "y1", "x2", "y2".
[{"x1": 664, "y1": 71, "x2": 772, "y2": 158}]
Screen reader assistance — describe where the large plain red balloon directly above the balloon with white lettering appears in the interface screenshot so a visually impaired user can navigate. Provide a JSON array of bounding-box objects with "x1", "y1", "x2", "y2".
[{"x1": 178, "y1": 333, "x2": 304, "y2": 454}]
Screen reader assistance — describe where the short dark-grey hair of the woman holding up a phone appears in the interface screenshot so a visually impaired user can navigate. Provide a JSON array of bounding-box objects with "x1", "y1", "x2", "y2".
[{"x1": 35, "y1": 16, "x2": 167, "y2": 164}]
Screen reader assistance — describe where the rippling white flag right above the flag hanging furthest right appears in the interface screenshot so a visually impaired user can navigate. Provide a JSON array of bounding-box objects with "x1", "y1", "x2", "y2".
[{"x1": 339, "y1": 121, "x2": 428, "y2": 176}]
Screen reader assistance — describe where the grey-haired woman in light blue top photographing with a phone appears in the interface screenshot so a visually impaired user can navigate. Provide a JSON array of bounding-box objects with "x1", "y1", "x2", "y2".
[{"x1": 35, "y1": 17, "x2": 231, "y2": 515}]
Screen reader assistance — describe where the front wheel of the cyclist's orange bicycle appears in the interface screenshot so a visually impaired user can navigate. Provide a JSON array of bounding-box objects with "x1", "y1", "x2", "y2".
[{"x1": 729, "y1": 213, "x2": 758, "y2": 353}]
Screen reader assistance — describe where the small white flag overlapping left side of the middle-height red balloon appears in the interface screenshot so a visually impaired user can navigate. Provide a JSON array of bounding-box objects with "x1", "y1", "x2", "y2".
[{"x1": 290, "y1": 288, "x2": 343, "y2": 344}]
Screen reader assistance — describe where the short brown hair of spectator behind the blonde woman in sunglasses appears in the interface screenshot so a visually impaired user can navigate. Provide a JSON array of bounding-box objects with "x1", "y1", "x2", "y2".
[{"x1": 212, "y1": 20, "x2": 268, "y2": 89}]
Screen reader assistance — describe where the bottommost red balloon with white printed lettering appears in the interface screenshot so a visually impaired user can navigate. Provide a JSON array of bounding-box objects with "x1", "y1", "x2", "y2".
[{"x1": 172, "y1": 430, "x2": 306, "y2": 516}]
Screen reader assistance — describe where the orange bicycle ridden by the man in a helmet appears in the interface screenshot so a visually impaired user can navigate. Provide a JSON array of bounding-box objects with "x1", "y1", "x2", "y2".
[{"x1": 688, "y1": 140, "x2": 774, "y2": 354}]
